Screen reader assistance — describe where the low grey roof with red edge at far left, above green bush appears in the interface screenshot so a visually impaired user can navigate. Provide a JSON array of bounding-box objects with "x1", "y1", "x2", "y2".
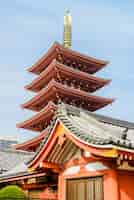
[{"x1": 0, "y1": 149, "x2": 41, "y2": 183}]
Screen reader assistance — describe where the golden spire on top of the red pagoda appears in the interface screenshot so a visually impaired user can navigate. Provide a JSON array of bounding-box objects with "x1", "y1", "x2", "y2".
[{"x1": 63, "y1": 10, "x2": 72, "y2": 48}]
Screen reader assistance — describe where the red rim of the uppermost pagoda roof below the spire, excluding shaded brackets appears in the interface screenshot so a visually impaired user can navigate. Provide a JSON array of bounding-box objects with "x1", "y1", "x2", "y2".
[{"x1": 28, "y1": 42, "x2": 108, "y2": 74}]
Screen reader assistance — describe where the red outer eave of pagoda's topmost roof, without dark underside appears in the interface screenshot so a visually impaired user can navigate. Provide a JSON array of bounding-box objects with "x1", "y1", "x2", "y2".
[{"x1": 28, "y1": 42, "x2": 109, "y2": 74}]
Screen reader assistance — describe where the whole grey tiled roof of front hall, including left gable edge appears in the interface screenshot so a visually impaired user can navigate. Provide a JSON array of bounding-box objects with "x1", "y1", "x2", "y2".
[{"x1": 29, "y1": 104, "x2": 134, "y2": 167}]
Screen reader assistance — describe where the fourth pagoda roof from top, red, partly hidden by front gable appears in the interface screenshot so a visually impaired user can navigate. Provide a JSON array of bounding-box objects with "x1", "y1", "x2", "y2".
[{"x1": 16, "y1": 101, "x2": 57, "y2": 131}]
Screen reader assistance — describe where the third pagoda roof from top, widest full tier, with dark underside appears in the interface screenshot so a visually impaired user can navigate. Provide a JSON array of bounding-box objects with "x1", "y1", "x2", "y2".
[{"x1": 22, "y1": 79, "x2": 114, "y2": 111}]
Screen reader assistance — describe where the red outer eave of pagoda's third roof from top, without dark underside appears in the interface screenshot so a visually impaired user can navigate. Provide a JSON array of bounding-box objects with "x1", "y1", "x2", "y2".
[{"x1": 22, "y1": 79, "x2": 114, "y2": 111}]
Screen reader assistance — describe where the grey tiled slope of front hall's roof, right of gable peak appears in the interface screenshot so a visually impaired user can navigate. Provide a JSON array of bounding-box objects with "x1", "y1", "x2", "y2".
[{"x1": 57, "y1": 104, "x2": 134, "y2": 149}]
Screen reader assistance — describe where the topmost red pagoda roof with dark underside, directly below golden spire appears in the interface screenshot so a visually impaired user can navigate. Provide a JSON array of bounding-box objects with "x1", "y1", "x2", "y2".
[{"x1": 28, "y1": 42, "x2": 108, "y2": 74}]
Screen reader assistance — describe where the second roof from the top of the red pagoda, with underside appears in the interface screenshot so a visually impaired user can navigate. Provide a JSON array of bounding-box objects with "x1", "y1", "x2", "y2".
[{"x1": 25, "y1": 59, "x2": 110, "y2": 92}]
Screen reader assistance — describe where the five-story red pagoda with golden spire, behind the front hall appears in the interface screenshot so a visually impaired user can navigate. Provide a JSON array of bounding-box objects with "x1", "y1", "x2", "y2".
[{"x1": 16, "y1": 11, "x2": 113, "y2": 151}]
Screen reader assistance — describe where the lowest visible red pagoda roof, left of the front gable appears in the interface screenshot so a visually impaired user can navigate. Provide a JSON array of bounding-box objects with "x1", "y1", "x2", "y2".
[{"x1": 13, "y1": 129, "x2": 48, "y2": 151}]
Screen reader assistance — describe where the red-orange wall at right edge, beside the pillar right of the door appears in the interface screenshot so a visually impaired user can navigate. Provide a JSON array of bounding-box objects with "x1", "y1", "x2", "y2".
[{"x1": 118, "y1": 172, "x2": 134, "y2": 200}]
